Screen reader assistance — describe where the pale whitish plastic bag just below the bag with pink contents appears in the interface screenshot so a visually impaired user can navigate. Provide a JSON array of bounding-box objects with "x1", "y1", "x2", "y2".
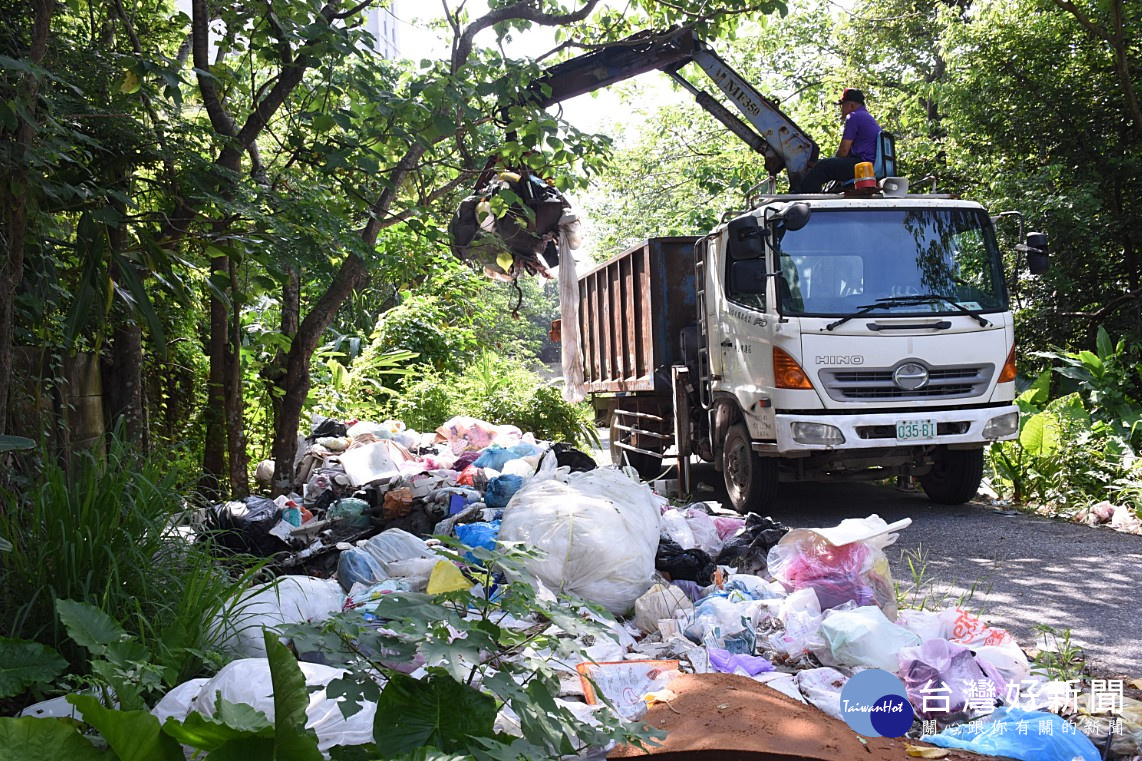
[{"x1": 817, "y1": 606, "x2": 920, "y2": 673}]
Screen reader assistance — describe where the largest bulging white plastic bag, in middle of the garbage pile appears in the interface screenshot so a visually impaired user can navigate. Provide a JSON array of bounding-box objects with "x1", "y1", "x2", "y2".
[{"x1": 499, "y1": 468, "x2": 666, "y2": 614}]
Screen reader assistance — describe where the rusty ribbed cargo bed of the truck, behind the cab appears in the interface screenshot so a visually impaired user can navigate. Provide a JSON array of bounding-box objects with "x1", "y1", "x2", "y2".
[{"x1": 579, "y1": 235, "x2": 698, "y2": 393}]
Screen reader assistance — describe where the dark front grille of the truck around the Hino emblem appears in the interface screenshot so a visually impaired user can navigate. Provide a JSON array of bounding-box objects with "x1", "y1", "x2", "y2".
[{"x1": 820, "y1": 365, "x2": 995, "y2": 401}]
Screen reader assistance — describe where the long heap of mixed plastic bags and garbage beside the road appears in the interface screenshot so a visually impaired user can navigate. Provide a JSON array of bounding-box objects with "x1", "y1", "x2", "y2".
[{"x1": 166, "y1": 417, "x2": 1142, "y2": 761}]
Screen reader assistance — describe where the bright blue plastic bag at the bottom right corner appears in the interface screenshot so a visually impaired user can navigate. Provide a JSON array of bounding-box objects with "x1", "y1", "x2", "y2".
[{"x1": 920, "y1": 706, "x2": 1102, "y2": 761}]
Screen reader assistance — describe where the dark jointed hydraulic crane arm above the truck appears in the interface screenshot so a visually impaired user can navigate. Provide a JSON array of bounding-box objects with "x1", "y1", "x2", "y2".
[{"x1": 530, "y1": 30, "x2": 819, "y2": 187}]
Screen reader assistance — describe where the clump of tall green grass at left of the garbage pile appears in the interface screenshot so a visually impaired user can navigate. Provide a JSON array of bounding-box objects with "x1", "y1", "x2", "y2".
[{"x1": 0, "y1": 431, "x2": 258, "y2": 684}]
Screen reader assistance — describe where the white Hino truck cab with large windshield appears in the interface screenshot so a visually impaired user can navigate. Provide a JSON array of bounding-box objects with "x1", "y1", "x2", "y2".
[{"x1": 708, "y1": 194, "x2": 1019, "y2": 507}]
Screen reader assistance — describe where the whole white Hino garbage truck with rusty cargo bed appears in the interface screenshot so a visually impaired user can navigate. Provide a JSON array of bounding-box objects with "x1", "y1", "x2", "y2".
[{"x1": 579, "y1": 196, "x2": 1046, "y2": 512}]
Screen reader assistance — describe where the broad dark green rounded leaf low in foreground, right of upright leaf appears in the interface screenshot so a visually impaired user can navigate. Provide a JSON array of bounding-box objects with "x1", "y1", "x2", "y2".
[{"x1": 372, "y1": 671, "x2": 496, "y2": 754}]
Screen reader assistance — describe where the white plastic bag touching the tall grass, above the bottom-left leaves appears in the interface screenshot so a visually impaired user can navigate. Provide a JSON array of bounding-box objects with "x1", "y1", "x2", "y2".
[{"x1": 211, "y1": 576, "x2": 345, "y2": 657}]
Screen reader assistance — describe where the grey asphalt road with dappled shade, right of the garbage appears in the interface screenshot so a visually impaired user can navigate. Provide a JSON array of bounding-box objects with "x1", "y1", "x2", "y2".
[{"x1": 596, "y1": 431, "x2": 1142, "y2": 679}]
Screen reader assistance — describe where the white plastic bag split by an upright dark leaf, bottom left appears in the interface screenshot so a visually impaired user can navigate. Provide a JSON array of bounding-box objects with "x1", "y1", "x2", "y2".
[{"x1": 151, "y1": 658, "x2": 377, "y2": 755}]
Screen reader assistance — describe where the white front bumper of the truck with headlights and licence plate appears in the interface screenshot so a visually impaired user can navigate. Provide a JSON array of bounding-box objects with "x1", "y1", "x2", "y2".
[{"x1": 767, "y1": 404, "x2": 1019, "y2": 455}]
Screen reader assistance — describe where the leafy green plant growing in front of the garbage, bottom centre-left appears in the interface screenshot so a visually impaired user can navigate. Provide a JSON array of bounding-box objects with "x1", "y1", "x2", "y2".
[{"x1": 279, "y1": 539, "x2": 653, "y2": 761}]
